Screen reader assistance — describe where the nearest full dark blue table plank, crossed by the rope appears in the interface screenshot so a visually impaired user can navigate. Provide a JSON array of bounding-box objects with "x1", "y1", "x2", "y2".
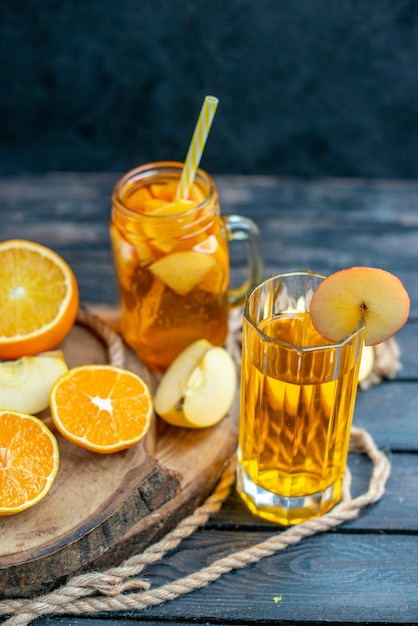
[{"x1": 118, "y1": 531, "x2": 418, "y2": 624}]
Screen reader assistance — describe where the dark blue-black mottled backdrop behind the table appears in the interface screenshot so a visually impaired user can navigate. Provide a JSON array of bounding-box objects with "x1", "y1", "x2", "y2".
[{"x1": 0, "y1": 0, "x2": 418, "y2": 178}]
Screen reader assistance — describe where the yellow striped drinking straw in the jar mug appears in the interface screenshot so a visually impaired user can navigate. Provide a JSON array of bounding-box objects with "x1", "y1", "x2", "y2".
[{"x1": 176, "y1": 96, "x2": 218, "y2": 200}]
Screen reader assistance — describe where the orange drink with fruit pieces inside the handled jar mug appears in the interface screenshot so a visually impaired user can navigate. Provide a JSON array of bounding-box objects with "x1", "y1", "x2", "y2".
[{"x1": 110, "y1": 181, "x2": 229, "y2": 370}]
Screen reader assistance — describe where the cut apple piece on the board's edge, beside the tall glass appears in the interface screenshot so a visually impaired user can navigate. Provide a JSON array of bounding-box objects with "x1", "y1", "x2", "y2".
[{"x1": 154, "y1": 339, "x2": 237, "y2": 428}]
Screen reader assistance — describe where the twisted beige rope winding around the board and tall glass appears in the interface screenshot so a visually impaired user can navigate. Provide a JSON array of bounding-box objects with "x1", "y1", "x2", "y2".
[{"x1": 0, "y1": 309, "x2": 398, "y2": 626}]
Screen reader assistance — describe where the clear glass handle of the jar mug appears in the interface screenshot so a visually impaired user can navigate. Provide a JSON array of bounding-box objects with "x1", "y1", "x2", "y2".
[{"x1": 222, "y1": 215, "x2": 264, "y2": 307}]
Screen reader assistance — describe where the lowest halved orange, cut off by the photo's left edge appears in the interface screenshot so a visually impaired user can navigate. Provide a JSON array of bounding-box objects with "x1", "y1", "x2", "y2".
[{"x1": 0, "y1": 411, "x2": 59, "y2": 515}]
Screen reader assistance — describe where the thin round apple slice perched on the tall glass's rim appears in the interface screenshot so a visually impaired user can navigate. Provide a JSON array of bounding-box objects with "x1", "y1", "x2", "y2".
[{"x1": 309, "y1": 267, "x2": 410, "y2": 346}]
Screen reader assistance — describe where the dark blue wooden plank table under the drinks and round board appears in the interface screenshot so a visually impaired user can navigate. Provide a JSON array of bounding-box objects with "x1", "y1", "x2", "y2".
[{"x1": 0, "y1": 173, "x2": 418, "y2": 626}]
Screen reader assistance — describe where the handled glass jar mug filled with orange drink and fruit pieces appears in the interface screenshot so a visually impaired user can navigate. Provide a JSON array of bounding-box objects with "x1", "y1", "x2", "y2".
[{"x1": 110, "y1": 161, "x2": 264, "y2": 371}]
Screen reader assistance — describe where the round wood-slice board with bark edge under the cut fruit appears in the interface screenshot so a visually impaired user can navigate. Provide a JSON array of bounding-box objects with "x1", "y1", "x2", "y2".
[{"x1": 0, "y1": 312, "x2": 238, "y2": 598}]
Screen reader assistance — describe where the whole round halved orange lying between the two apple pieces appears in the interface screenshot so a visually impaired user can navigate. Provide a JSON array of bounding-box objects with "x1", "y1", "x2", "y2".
[{"x1": 50, "y1": 365, "x2": 153, "y2": 453}]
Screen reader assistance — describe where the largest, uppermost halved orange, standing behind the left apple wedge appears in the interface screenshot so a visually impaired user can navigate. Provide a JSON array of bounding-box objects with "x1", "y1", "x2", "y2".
[{"x1": 0, "y1": 239, "x2": 79, "y2": 359}]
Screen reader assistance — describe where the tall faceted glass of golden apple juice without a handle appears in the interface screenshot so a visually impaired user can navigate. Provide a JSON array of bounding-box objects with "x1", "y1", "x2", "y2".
[{"x1": 237, "y1": 272, "x2": 365, "y2": 526}]
